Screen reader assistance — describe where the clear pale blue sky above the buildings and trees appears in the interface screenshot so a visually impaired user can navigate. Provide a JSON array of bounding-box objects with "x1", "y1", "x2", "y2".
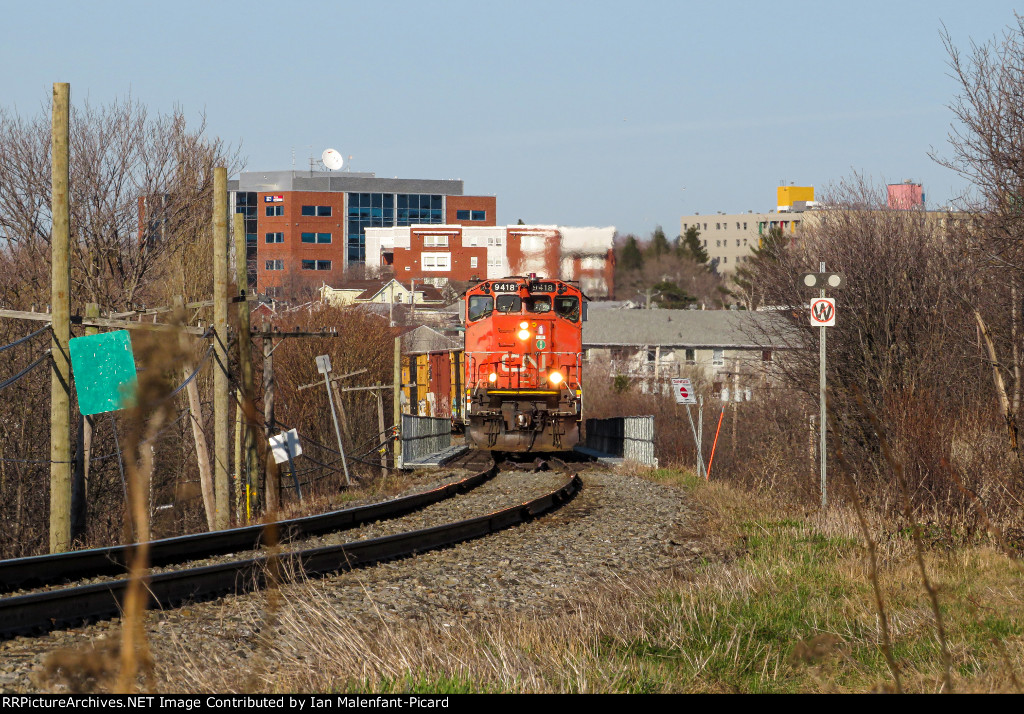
[{"x1": 0, "y1": 0, "x2": 1015, "y2": 236}]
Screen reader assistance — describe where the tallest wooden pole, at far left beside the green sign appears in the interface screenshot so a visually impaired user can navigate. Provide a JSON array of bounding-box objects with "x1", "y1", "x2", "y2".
[{"x1": 50, "y1": 82, "x2": 71, "y2": 553}]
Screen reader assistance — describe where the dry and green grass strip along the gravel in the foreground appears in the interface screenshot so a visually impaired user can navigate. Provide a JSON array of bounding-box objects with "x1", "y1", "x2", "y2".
[{"x1": 138, "y1": 463, "x2": 1024, "y2": 692}]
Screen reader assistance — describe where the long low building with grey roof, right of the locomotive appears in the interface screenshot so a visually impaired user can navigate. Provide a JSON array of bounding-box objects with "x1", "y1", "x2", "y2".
[{"x1": 583, "y1": 309, "x2": 799, "y2": 398}]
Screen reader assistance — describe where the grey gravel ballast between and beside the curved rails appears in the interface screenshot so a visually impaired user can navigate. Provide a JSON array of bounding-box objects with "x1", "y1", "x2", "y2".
[{"x1": 0, "y1": 466, "x2": 689, "y2": 692}]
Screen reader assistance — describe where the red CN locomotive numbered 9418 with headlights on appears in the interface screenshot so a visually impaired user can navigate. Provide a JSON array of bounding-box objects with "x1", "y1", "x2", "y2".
[{"x1": 463, "y1": 275, "x2": 587, "y2": 452}]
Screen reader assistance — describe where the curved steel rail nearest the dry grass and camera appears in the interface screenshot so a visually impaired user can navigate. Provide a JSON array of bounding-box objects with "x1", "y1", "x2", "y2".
[{"x1": 0, "y1": 474, "x2": 583, "y2": 639}]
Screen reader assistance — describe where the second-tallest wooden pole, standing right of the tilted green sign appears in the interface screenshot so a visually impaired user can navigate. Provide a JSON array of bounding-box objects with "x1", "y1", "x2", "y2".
[{"x1": 213, "y1": 166, "x2": 231, "y2": 530}]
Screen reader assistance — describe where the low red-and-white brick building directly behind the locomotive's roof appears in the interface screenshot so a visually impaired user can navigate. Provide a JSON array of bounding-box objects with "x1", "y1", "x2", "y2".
[{"x1": 366, "y1": 224, "x2": 615, "y2": 298}]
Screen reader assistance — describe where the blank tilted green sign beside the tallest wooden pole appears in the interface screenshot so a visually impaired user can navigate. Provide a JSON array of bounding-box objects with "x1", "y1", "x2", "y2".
[{"x1": 68, "y1": 330, "x2": 137, "y2": 416}]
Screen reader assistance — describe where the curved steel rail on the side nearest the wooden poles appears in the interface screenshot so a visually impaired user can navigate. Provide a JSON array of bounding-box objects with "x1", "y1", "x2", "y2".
[{"x1": 0, "y1": 456, "x2": 498, "y2": 592}]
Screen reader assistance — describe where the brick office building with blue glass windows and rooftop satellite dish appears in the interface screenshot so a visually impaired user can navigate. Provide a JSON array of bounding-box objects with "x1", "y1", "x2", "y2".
[{"x1": 228, "y1": 171, "x2": 497, "y2": 297}]
